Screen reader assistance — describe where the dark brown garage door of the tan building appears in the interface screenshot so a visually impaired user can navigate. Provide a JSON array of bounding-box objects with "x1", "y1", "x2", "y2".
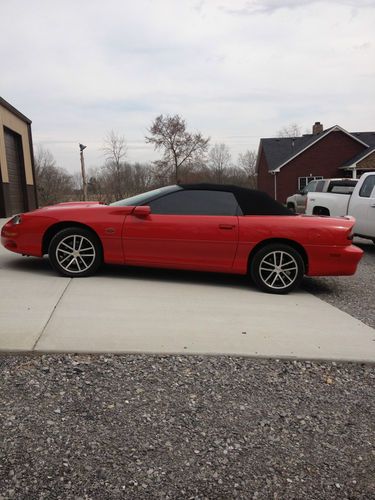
[{"x1": 4, "y1": 130, "x2": 25, "y2": 215}]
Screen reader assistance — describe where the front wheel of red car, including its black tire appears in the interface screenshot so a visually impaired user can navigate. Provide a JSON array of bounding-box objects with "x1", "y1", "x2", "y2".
[{"x1": 48, "y1": 227, "x2": 103, "y2": 278}]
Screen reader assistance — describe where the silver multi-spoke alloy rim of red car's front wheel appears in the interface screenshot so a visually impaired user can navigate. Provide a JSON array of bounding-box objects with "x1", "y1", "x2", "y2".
[{"x1": 55, "y1": 234, "x2": 96, "y2": 274}]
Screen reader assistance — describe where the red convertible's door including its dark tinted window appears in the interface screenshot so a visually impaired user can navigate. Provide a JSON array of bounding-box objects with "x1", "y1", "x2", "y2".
[{"x1": 123, "y1": 189, "x2": 240, "y2": 271}]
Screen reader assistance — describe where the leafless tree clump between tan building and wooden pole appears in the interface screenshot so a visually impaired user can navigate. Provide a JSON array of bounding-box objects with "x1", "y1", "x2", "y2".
[{"x1": 34, "y1": 146, "x2": 73, "y2": 206}]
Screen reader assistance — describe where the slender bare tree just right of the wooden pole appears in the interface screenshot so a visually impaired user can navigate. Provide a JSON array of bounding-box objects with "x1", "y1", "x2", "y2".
[{"x1": 102, "y1": 130, "x2": 127, "y2": 199}]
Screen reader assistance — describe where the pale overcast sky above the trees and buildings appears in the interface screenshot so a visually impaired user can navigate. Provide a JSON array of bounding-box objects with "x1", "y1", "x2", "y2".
[{"x1": 0, "y1": 0, "x2": 375, "y2": 172}]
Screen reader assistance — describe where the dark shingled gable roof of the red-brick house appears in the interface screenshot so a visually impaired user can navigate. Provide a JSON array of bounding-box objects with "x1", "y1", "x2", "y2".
[{"x1": 260, "y1": 125, "x2": 375, "y2": 172}]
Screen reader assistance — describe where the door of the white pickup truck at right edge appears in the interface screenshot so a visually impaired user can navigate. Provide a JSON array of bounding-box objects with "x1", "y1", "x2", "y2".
[{"x1": 348, "y1": 174, "x2": 375, "y2": 238}]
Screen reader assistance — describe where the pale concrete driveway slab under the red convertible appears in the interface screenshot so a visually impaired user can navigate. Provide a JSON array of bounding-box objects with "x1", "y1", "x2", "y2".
[{"x1": 0, "y1": 220, "x2": 375, "y2": 361}]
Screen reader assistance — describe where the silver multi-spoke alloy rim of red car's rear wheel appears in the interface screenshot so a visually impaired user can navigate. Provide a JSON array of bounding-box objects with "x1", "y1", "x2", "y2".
[{"x1": 259, "y1": 250, "x2": 299, "y2": 290}]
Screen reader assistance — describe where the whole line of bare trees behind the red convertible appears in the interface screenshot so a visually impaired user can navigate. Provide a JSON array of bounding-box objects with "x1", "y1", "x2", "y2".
[{"x1": 34, "y1": 115, "x2": 257, "y2": 206}]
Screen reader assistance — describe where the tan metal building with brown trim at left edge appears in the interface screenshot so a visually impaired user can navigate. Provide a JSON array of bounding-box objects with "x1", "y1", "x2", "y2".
[{"x1": 0, "y1": 97, "x2": 37, "y2": 217}]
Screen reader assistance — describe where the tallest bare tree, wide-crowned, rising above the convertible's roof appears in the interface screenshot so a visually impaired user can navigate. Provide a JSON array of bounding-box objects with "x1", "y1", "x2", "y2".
[{"x1": 145, "y1": 115, "x2": 210, "y2": 182}]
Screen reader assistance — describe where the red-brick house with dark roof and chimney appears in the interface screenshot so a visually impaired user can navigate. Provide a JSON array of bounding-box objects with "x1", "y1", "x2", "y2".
[{"x1": 257, "y1": 122, "x2": 375, "y2": 203}]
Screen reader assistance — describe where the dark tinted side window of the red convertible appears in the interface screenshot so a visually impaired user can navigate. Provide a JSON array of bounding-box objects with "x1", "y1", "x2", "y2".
[{"x1": 149, "y1": 189, "x2": 242, "y2": 215}]
